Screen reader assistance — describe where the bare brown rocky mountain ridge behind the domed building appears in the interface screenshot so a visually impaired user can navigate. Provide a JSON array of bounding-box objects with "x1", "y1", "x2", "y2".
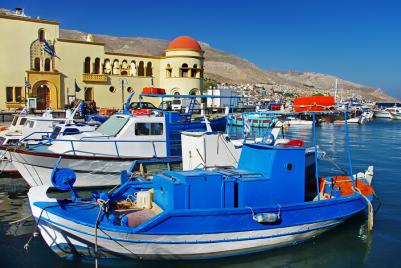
[{"x1": 60, "y1": 29, "x2": 395, "y2": 101}]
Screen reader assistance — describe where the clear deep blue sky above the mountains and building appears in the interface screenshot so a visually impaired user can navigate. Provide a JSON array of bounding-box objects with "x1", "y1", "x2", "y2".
[{"x1": 0, "y1": 0, "x2": 401, "y2": 99}]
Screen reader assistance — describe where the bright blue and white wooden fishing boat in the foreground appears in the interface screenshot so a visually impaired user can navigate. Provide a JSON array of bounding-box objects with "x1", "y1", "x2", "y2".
[{"x1": 28, "y1": 110, "x2": 376, "y2": 261}]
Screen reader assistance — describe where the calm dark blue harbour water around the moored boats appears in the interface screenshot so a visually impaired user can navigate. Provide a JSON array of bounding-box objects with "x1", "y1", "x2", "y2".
[{"x1": 0, "y1": 120, "x2": 401, "y2": 268}]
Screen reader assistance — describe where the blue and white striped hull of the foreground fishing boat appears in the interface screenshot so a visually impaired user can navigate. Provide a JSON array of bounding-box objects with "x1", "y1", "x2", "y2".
[{"x1": 28, "y1": 187, "x2": 367, "y2": 260}]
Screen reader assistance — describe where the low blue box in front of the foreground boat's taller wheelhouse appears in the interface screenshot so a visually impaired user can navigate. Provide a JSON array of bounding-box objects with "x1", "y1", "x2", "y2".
[{"x1": 153, "y1": 170, "x2": 228, "y2": 209}]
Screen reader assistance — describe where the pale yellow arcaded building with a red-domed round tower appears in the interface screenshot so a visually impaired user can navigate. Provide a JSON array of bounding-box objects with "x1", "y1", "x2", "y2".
[{"x1": 0, "y1": 9, "x2": 204, "y2": 110}]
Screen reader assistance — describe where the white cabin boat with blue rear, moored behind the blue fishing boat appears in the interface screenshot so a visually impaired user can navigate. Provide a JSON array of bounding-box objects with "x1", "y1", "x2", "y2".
[{"x1": 9, "y1": 95, "x2": 226, "y2": 187}]
